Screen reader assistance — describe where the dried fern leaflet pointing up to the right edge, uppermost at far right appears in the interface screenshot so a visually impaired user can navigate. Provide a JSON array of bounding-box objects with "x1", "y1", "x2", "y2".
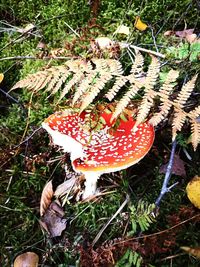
[{"x1": 174, "y1": 75, "x2": 197, "y2": 108}]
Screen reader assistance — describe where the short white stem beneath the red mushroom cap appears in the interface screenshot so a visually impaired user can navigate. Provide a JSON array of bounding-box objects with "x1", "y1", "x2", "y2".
[{"x1": 83, "y1": 172, "x2": 100, "y2": 199}]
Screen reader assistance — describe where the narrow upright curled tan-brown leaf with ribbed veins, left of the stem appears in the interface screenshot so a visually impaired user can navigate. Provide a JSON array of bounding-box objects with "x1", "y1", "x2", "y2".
[{"x1": 40, "y1": 180, "x2": 54, "y2": 216}]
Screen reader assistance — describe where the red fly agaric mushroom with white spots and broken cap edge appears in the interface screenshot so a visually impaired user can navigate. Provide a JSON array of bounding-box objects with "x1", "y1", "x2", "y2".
[{"x1": 42, "y1": 108, "x2": 154, "y2": 199}]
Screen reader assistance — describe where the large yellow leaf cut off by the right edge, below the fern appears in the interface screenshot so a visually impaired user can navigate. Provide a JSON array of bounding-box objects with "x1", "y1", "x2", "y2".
[{"x1": 186, "y1": 175, "x2": 200, "y2": 209}]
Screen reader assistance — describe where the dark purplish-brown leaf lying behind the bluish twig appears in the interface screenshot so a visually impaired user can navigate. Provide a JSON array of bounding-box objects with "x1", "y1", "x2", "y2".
[{"x1": 159, "y1": 155, "x2": 186, "y2": 177}]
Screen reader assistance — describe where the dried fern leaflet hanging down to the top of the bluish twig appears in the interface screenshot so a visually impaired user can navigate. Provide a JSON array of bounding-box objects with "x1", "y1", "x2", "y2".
[{"x1": 172, "y1": 108, "x2": 187, "y2": 141}]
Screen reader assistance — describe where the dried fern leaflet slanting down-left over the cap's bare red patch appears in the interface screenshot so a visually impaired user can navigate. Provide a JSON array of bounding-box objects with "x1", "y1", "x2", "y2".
[{"x1": 111, "y1": 85, "x2": 140, "y2": 120}]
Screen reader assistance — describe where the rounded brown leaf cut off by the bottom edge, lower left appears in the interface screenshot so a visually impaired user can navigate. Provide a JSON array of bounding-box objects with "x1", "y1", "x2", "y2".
[{"x1": 14, "y1": 252, "x2": 39, "y2": 267}]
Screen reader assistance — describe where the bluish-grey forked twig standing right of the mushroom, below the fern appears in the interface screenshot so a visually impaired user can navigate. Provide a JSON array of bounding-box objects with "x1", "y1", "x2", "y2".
[{"x1": 155, "y1": 140, "x2": 177, "y2": 207}]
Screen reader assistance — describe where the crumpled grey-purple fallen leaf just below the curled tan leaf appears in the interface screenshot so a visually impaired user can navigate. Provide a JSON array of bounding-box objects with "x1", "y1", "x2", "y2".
[{"x1": 39, "y1": 202, "x2": 67, "y2": 237}]
